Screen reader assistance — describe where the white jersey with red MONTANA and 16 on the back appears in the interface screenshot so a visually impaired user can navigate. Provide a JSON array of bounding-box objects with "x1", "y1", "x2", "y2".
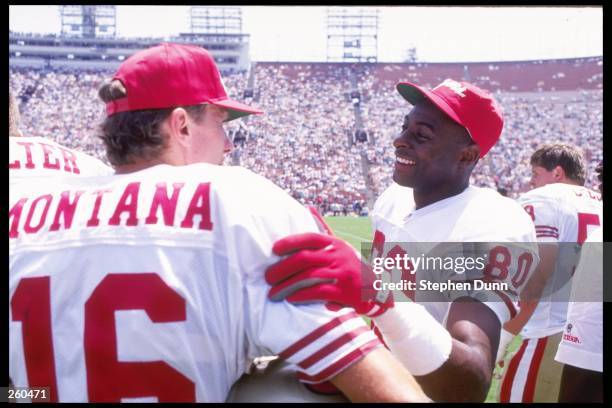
[{"x1": 9, "y1": 164, "x2": 380, "y2": 402}]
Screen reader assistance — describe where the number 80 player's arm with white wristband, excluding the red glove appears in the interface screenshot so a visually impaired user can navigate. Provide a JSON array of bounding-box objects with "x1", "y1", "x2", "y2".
[{"x1": 373, "y1": 297, "x2": 500, "y2": 402}]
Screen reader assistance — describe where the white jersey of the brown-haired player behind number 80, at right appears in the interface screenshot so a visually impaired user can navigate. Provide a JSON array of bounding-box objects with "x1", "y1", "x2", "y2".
[{"x1": 518, "y1": 183, "x2": 603, "y2": 338}]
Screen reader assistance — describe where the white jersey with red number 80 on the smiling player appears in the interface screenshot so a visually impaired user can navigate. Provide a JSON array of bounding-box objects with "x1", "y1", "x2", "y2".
[{"x1": 372, "y1": 183, "x2": 539, "y2": 323}]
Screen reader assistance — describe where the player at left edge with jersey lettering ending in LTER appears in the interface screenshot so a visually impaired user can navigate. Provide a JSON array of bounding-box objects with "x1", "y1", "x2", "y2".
[{"x1": 9, "y1": 90, "x2": 113, "y2": 184}]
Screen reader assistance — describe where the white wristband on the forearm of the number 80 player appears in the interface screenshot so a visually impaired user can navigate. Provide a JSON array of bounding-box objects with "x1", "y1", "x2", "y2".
[{"x1": 373, "y1": 302, "x2": 453, "y2": 375}]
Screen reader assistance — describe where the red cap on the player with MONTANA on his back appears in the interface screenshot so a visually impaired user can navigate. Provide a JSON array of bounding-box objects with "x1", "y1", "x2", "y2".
[{"x1": 106, "y1": 43, "x2": 263, "y2": 121}]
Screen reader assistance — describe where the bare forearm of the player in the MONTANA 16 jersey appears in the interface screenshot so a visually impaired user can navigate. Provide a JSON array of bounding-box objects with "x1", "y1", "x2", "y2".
[{"x1": 331, "y1": 347, "x2": 429, "y2": 402}]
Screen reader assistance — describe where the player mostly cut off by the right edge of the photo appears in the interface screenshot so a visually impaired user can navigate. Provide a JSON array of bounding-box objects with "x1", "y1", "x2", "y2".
[{"x1": 555, "y1": 162, "x2": 604, "y2": 403}]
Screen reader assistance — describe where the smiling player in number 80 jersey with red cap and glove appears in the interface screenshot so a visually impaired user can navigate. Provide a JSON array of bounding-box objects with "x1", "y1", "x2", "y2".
[{"x1": 266, "y1": 79, "x2": 538, "y2": 401}]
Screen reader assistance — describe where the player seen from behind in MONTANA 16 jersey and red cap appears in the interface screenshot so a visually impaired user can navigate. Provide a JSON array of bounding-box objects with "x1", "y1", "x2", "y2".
[{"x1": 9, "y1": 43, "x2": 427, "y2": 402}]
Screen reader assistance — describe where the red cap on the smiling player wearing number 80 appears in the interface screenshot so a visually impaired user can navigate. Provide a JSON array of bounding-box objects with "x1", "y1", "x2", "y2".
[{"x1": 396, "y1": 79, "x2": 504, "y2": 157}]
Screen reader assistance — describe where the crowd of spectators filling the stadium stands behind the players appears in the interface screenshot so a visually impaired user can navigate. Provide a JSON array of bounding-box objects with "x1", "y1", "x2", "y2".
[{"x1": 9, "y1": 59, "x2": 603, "y2": 217}]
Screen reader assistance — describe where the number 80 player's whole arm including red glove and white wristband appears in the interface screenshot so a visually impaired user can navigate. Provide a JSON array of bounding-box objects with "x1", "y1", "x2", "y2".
[{"x1": 266, "y1": 234, "x2": 544, "y2": 401}]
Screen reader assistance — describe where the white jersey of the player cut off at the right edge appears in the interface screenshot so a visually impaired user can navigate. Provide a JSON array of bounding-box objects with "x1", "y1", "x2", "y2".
[{"x1": 555, "y1": 227, "x2": 603, "y2": 372}]
